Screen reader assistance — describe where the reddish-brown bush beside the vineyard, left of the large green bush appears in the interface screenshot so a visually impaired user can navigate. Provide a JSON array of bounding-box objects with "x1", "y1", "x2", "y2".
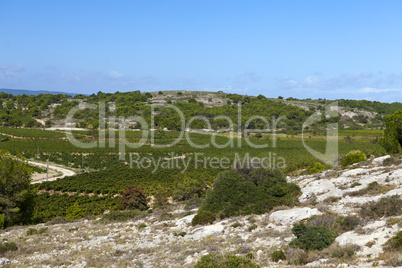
[{"x1": 120, "y1": 185, "x2": 148, "y2": 210}]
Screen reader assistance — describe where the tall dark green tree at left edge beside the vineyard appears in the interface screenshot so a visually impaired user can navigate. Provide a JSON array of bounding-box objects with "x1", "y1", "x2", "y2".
[{"x1": 0, "y1": 151, "x2": 34, "y2": 226}]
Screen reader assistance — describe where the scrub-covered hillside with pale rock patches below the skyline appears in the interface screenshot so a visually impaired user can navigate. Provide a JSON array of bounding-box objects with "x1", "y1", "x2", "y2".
[{"x1": 0, "y1": 91, "x2": 402, "y2": 134}]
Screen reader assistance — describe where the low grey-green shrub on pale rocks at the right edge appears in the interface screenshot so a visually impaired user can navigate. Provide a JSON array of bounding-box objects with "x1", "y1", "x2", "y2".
[{"x1": 360, "y1": 195, "x2": 402, "y2": 219}]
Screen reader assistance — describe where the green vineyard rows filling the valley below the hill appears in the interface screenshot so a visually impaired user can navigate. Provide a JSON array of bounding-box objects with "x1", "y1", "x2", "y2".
[{"x1": 0, "y1": 127, "x2": 381, "y2": 222}]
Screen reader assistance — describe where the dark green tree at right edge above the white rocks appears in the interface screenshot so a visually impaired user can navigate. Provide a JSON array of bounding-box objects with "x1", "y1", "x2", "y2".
[{"x1": 381, "y1": 110, "x2": 402, "y2": 154}]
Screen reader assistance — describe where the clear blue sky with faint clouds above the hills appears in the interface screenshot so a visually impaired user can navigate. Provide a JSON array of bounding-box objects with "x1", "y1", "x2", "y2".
[{"x1": 0, "y1": 0, "x2": 402, "y2": 102}]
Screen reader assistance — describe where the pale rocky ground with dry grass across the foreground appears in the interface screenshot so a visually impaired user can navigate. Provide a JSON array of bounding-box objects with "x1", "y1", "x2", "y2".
[{"x1": 0, "y1": 157, "x2": 402, "y2": 267}]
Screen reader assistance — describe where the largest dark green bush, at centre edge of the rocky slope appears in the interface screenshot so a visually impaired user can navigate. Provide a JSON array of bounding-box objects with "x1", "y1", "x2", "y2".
[{"x1": 199, "y1": 169, "x2": 300, "y2": 218}]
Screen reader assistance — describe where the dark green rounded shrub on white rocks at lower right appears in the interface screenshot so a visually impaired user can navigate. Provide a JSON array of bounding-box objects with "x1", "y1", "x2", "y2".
[{"x1": 289, "y1": 223, "x2": 338, "y2": 251}]
